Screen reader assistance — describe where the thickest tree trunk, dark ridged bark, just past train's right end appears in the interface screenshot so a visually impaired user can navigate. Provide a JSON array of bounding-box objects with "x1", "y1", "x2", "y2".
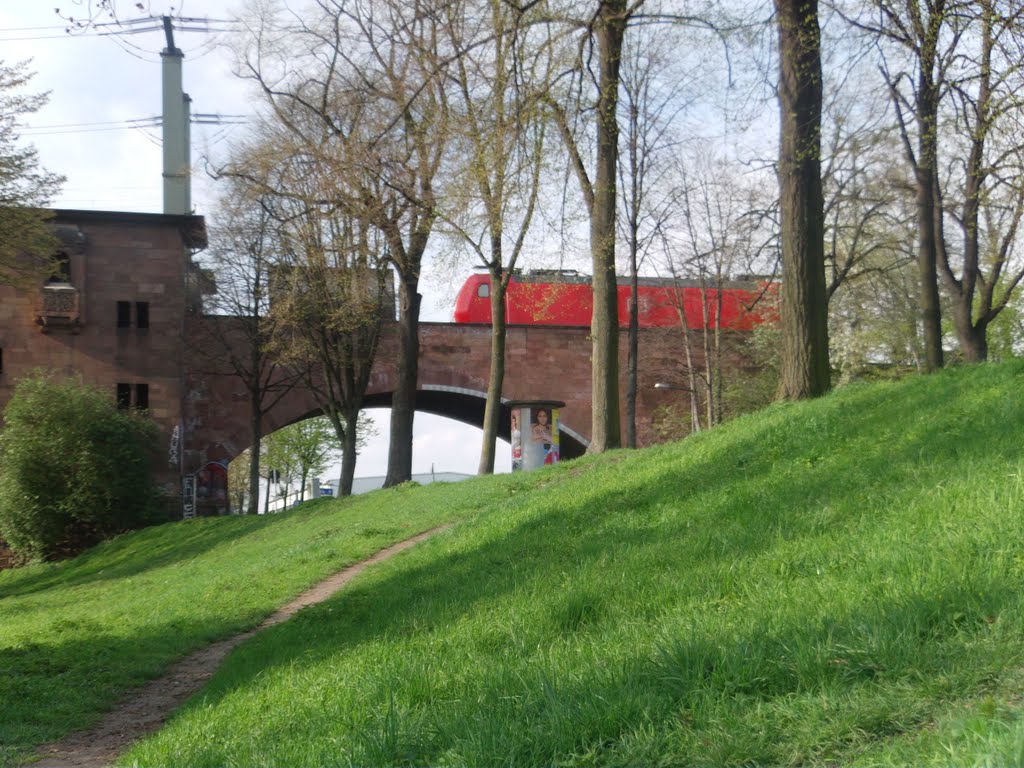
[{"x1": 775, "y1": 0, "x2": 830, "y2": 399}]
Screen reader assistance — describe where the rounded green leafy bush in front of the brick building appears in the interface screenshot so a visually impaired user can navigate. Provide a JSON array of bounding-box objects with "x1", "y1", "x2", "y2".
[{"x1": 0, "y1": 374, "x2": 157, "y2": 559}]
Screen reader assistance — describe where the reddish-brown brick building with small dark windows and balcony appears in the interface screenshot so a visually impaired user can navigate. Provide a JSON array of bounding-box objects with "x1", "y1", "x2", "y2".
[{"x1": 0, "y1": 210, "x2": 206, "y2": 503}]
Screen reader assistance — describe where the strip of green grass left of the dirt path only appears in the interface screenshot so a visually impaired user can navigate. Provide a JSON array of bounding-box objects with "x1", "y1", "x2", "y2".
[{"x1": 0, "y1": 486, "x2": 487, "y2": 767}]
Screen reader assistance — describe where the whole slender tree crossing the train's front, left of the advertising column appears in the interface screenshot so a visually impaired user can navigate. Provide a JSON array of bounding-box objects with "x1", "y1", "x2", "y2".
[{"x1": 441, "y1": 2, "x2": 551, "y2": 474}]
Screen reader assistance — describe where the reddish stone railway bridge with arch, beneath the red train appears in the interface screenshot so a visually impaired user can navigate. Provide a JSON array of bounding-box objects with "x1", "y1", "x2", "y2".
[{"x1": 182, "y1": 317, "x2": 729, "y2": 467}]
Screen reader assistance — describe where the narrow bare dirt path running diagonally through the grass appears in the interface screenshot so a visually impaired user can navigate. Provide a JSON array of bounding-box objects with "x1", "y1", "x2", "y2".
[{"x1": 27, "y1": 525, "x2": 447, "y2": 768}]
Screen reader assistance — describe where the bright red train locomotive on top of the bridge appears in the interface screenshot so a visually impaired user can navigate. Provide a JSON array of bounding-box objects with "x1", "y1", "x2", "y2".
[{"x1": 455, "y1": 269, "x2": 769, "y2": 331}]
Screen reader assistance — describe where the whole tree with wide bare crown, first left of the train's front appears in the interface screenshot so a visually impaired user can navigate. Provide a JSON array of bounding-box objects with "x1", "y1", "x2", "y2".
[{"x1": 234, "y1": 0, "x2": 450, "y2": 485}]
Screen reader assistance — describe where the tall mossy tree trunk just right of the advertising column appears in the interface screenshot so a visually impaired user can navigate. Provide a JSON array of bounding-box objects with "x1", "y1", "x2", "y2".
[{"x1": 589, "y1": 0, "x2": 627, "y2": 453}]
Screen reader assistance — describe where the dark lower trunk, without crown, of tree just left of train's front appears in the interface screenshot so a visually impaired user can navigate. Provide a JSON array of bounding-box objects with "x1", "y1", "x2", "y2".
[{"x1": 384, "y1": 275, "x2": 423, "y2": 487}]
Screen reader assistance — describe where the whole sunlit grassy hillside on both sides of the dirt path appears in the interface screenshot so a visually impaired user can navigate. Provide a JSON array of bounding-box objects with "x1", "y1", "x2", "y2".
[{"x1": 0, "y1": 362, "x2": 1024, "y2": 767}]
